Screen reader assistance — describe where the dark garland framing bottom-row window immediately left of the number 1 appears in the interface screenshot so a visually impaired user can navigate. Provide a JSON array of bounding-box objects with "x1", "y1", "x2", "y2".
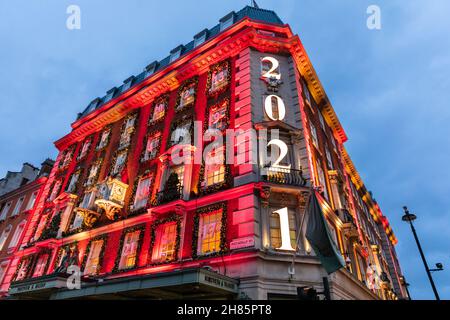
[{"x1": 192, "y1": 202, "x2": 227, "y2": 259}]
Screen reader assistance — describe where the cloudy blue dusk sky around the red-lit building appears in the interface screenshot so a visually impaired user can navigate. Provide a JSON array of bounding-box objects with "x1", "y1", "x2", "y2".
[{"x1": 0, "y1": 0, "x2": 450, "y2": 299}]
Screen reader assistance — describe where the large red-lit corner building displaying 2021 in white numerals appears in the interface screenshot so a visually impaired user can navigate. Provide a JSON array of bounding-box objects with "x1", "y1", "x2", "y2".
[{"x1": 5, "y1": 7, "x2": 405, "y2": 299}]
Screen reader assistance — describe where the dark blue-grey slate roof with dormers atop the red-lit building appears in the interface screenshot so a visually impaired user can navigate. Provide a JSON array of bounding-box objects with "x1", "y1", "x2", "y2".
[{"x1": 77, "y1": 6, "x2": 284, "y2": 120}]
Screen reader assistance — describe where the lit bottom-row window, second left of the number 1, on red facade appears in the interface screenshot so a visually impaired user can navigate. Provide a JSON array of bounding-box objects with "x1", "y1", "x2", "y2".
[{"x1": 152, "y1": 222, "x2": 177, "y2": 262}]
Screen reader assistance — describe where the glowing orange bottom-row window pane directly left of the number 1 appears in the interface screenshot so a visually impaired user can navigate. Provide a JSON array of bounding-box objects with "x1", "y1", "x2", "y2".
[{"x1": 197, "y1": 210, "x2": 222, "y2": 255}]
